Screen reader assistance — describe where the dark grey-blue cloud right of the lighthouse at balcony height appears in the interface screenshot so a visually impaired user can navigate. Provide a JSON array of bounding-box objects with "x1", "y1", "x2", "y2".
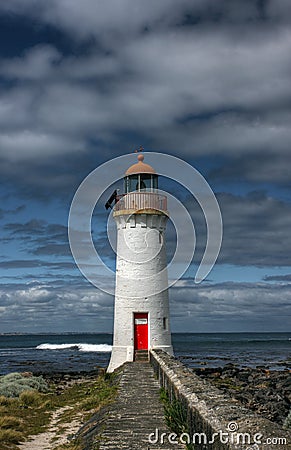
[{"x1": 171, "y1": 191, "x2": 291, "y2": 267}]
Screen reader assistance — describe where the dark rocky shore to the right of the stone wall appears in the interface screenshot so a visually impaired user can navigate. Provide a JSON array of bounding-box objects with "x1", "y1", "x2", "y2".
[{"x1": 193, "y1": 364, "x2": 291, "y2": 426}]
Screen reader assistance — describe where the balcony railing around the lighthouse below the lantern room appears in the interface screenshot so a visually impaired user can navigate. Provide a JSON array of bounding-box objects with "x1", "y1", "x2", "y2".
[{"x1": 114, "y1": 192, "x2": 167, "y2": 212}]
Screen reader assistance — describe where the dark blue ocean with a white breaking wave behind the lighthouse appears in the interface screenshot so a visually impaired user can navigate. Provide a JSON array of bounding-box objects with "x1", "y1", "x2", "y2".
[{"x1": 0, "y1": 333, "x2": 291, "y2": 375}]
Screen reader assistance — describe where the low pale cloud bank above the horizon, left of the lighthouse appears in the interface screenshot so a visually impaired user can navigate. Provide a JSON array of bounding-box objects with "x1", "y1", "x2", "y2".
[{"x1": 0, "y1": 283, "x2": 113, "y2": 332}]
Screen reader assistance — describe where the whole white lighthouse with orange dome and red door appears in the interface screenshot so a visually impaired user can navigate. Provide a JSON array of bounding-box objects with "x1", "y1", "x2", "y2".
[{"x1": 107, "y1": 153, "x2": 173, "y2": 372}]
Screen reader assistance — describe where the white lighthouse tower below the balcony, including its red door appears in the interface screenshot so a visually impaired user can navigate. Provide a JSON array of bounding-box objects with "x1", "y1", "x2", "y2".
[{"x1": 107, "y1": 212, "x2": 173, "y2": 372}]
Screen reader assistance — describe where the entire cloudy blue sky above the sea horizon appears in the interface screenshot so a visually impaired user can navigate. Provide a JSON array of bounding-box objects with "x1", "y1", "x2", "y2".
[{"x1": 0, "y1": 0, "x2": 291, "y2": 333}]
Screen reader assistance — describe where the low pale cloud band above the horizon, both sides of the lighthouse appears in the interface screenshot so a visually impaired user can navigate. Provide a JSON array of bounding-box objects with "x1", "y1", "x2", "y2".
[{"x1": 0, "y1": 282, "x2": 291, "y2": 332}]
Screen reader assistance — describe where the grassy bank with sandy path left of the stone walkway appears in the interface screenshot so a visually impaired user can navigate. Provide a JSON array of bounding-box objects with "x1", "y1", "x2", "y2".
[{"x1": 0, "y1": 375, "x2": 117, "y2": 450}]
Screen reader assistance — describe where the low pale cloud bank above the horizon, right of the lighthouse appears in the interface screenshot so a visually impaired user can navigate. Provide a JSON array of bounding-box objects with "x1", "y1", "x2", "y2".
[{"x1": 171, "y1": 281, "x2": 291, "y2": 332}]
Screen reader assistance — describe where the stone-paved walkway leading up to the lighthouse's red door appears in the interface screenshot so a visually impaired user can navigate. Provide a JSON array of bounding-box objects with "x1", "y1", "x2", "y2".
[{"x1": 99, "y1": 362, "x2": 185, "y2": 450}]
